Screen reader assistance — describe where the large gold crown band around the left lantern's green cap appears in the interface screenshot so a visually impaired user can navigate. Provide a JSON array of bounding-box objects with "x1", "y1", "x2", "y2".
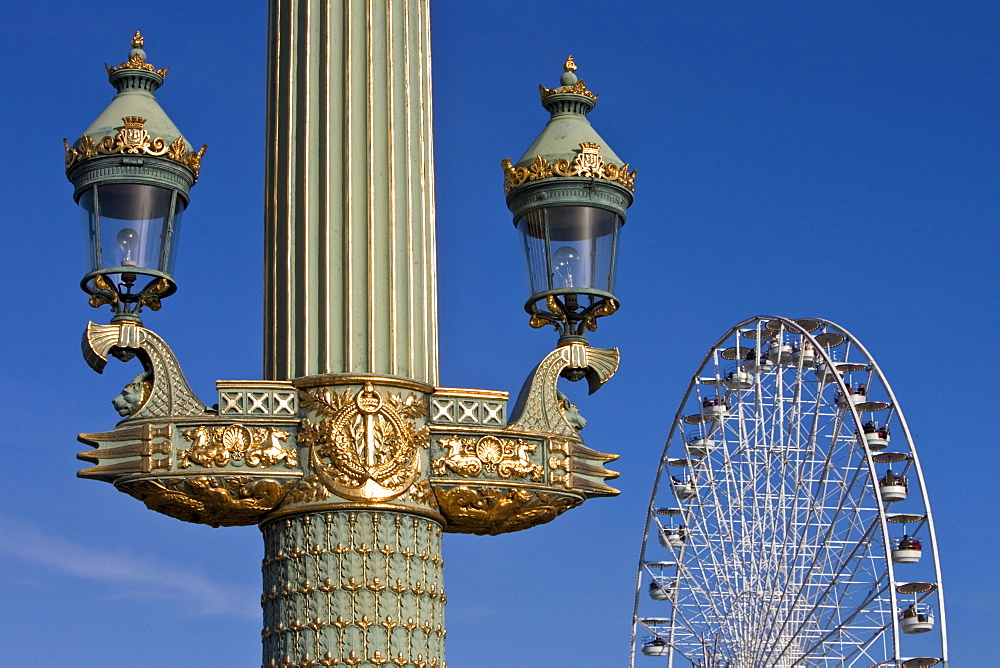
[{"x1": 63, "y1": 116, "x2": 208, "y2": 177}]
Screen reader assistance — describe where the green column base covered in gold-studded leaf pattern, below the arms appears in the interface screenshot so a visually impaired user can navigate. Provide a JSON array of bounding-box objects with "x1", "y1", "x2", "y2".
[{"x1": 261, "y1": 510, "x2": 445, "y2": 668}]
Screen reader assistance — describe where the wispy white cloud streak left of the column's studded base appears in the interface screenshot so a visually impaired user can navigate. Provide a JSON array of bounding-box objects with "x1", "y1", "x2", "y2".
[{"x1": 0, "y1": 516, "x2": 260, "y2": 618}]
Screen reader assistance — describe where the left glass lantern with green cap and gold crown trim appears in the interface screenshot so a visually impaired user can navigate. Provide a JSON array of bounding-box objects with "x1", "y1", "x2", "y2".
[{"x1": 63, "y1": 31, "x2": 207, "y2": 323}]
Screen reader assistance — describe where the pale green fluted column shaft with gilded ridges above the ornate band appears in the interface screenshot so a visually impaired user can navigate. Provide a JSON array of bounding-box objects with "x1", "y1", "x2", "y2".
[{"x1": 264, "y1": 0, "x2": 437, "y2": 385}]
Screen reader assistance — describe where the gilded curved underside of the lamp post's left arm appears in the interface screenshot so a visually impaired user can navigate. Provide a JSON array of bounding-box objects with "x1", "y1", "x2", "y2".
[{"x1": 118, "y1": 475, "x2": 295, "y2": 527}]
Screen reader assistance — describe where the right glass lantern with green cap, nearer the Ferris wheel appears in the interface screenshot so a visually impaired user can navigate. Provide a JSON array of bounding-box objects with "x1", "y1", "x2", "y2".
[{"x1": 501, "y1": 56, "x2": 636, "y2": 344}]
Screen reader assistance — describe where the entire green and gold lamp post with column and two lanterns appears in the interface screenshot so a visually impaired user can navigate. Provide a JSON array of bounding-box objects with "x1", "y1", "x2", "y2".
[{"x1": 66, "y1": 6, "x2": 634, "y2": 668}]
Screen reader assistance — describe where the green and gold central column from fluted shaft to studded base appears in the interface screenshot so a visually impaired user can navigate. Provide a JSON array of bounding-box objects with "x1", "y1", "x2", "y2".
[{"x1": 261, "y1": 0, "x2": 444, "y2": 666}]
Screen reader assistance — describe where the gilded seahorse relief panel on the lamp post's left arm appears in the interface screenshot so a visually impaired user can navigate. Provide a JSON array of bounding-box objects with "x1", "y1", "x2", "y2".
[{"x1": 177, "y1": 424, "x2": 299, "y2": 469}]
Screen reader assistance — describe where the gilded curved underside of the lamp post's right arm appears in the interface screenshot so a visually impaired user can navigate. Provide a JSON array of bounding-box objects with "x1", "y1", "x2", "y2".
[{"x1": 437, "y1": 486, "x2": 582, "y2": 536}]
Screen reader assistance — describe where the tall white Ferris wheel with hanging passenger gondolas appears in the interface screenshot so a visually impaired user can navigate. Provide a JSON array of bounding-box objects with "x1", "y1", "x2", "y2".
[{"x1": 630, "y1": 316, "x2": 948, "y2": 668}]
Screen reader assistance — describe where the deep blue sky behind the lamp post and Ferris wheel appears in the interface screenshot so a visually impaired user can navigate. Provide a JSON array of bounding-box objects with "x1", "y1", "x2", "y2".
[{"x1": 0, "y1": 0, "x2": 1000, "y2": 668}]
